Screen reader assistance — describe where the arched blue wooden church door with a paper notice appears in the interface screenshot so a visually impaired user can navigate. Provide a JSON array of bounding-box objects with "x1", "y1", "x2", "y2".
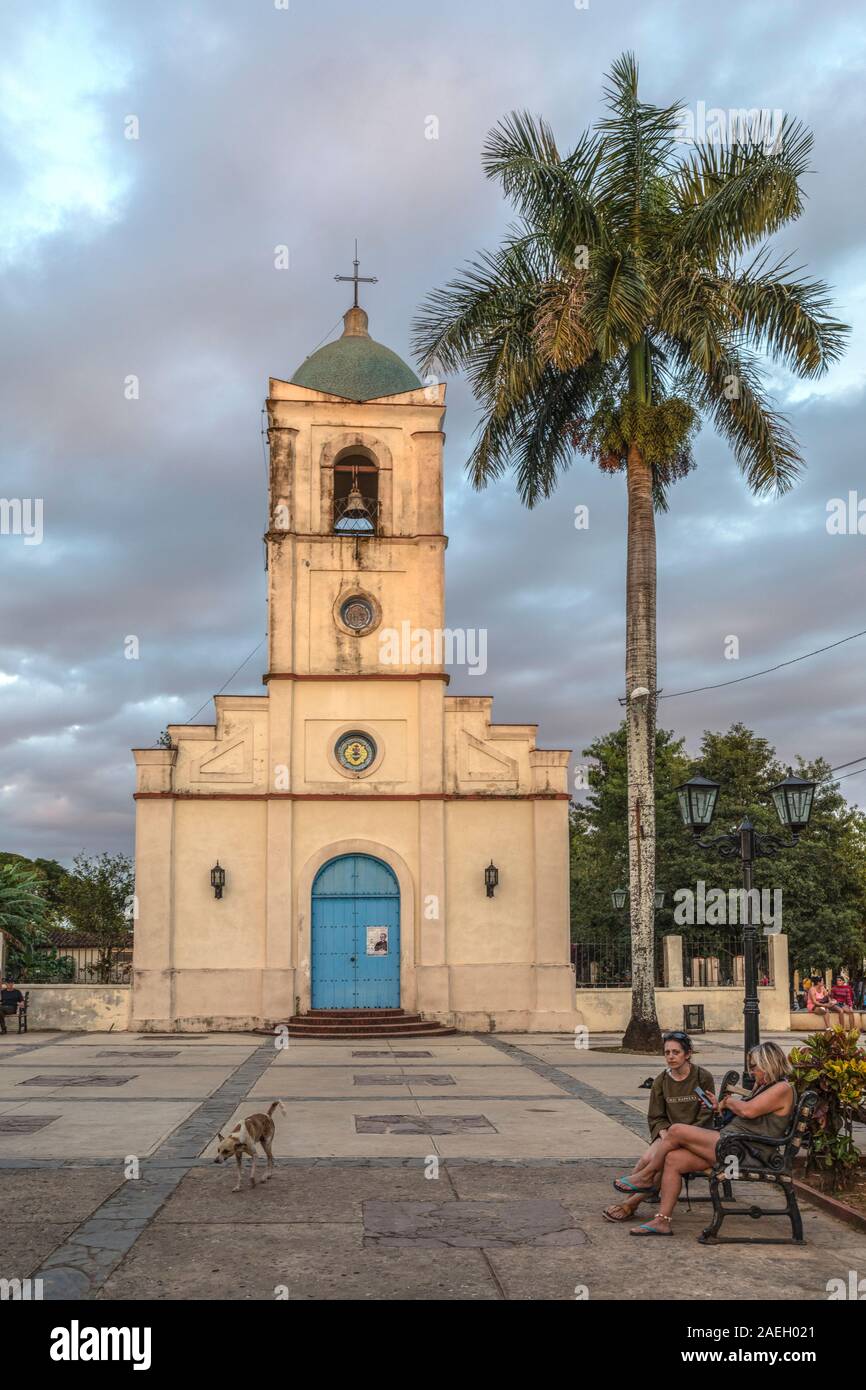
[{"x1": 311, "y1": 855, "x2": 400, "y2": 1009}]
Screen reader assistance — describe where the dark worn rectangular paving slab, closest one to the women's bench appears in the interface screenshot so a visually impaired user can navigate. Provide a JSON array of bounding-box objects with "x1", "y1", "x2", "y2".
[{"x1": 364, "y1": 1200, "x2": 587, "y2": 1250}]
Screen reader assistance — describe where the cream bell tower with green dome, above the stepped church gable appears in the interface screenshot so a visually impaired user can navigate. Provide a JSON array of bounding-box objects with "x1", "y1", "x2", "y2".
[{"x1": 265, "y1": 300, "x2": 446, "y2": 678}]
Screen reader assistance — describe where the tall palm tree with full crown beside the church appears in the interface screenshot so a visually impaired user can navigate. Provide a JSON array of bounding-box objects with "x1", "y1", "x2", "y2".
[{"x1": 414, "y1": 54, "x2": 847, "y2": 1049}]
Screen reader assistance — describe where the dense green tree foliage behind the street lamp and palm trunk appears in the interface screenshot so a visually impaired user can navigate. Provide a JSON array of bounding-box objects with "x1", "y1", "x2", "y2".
[{"x1": 571, "y1": 723, "x2": 866, "y2": 995}]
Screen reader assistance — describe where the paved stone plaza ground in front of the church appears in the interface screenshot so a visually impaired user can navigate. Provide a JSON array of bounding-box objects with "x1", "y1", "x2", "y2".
[{"x1": 0, "y1": 1033, "x2": 866, "y2": 1300}]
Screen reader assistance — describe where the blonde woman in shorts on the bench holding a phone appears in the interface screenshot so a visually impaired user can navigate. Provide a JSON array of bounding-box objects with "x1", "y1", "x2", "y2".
[{"x1": 630, "y1": 1043, "x2": 795, "y2": 1236}]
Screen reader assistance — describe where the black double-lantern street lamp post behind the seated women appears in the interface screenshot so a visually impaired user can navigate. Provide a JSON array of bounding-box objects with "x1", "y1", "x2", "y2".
[{"x1": 677, "y1": 769, "x2": 815, "y2": 1090}]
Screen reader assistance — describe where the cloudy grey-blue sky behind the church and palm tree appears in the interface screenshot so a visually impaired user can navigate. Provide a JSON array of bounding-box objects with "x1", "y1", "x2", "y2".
[{"x1": 0, "y1": 0, "x2": 866, "y2": 860}]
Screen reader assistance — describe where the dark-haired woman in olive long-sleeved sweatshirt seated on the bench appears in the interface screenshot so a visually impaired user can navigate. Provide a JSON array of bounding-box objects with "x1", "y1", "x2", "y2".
[{"x1": 602, "y1": 1033, "x2": 714, "y2": 1222}]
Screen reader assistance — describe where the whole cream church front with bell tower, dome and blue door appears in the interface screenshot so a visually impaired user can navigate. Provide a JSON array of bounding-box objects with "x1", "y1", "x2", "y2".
[{"x1": 132, "y1": 293, "x2": 577, "y2": 1031}]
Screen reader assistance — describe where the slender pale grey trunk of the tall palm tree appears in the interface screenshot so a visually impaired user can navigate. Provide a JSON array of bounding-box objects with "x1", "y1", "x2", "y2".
[{"x1": 623, "y1": 443, "x2": 662, "y2": 1052}]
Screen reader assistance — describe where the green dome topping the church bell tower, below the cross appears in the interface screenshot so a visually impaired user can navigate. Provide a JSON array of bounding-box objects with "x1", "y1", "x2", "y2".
[{"x1": 292, "y1": 309, "x2": 421, "y2": 400}]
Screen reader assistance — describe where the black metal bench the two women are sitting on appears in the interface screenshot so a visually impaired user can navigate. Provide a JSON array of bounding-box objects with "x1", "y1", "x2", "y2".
[{"x1": 698, "y1": 1091, "x2": 817, "y2": 1245}]
